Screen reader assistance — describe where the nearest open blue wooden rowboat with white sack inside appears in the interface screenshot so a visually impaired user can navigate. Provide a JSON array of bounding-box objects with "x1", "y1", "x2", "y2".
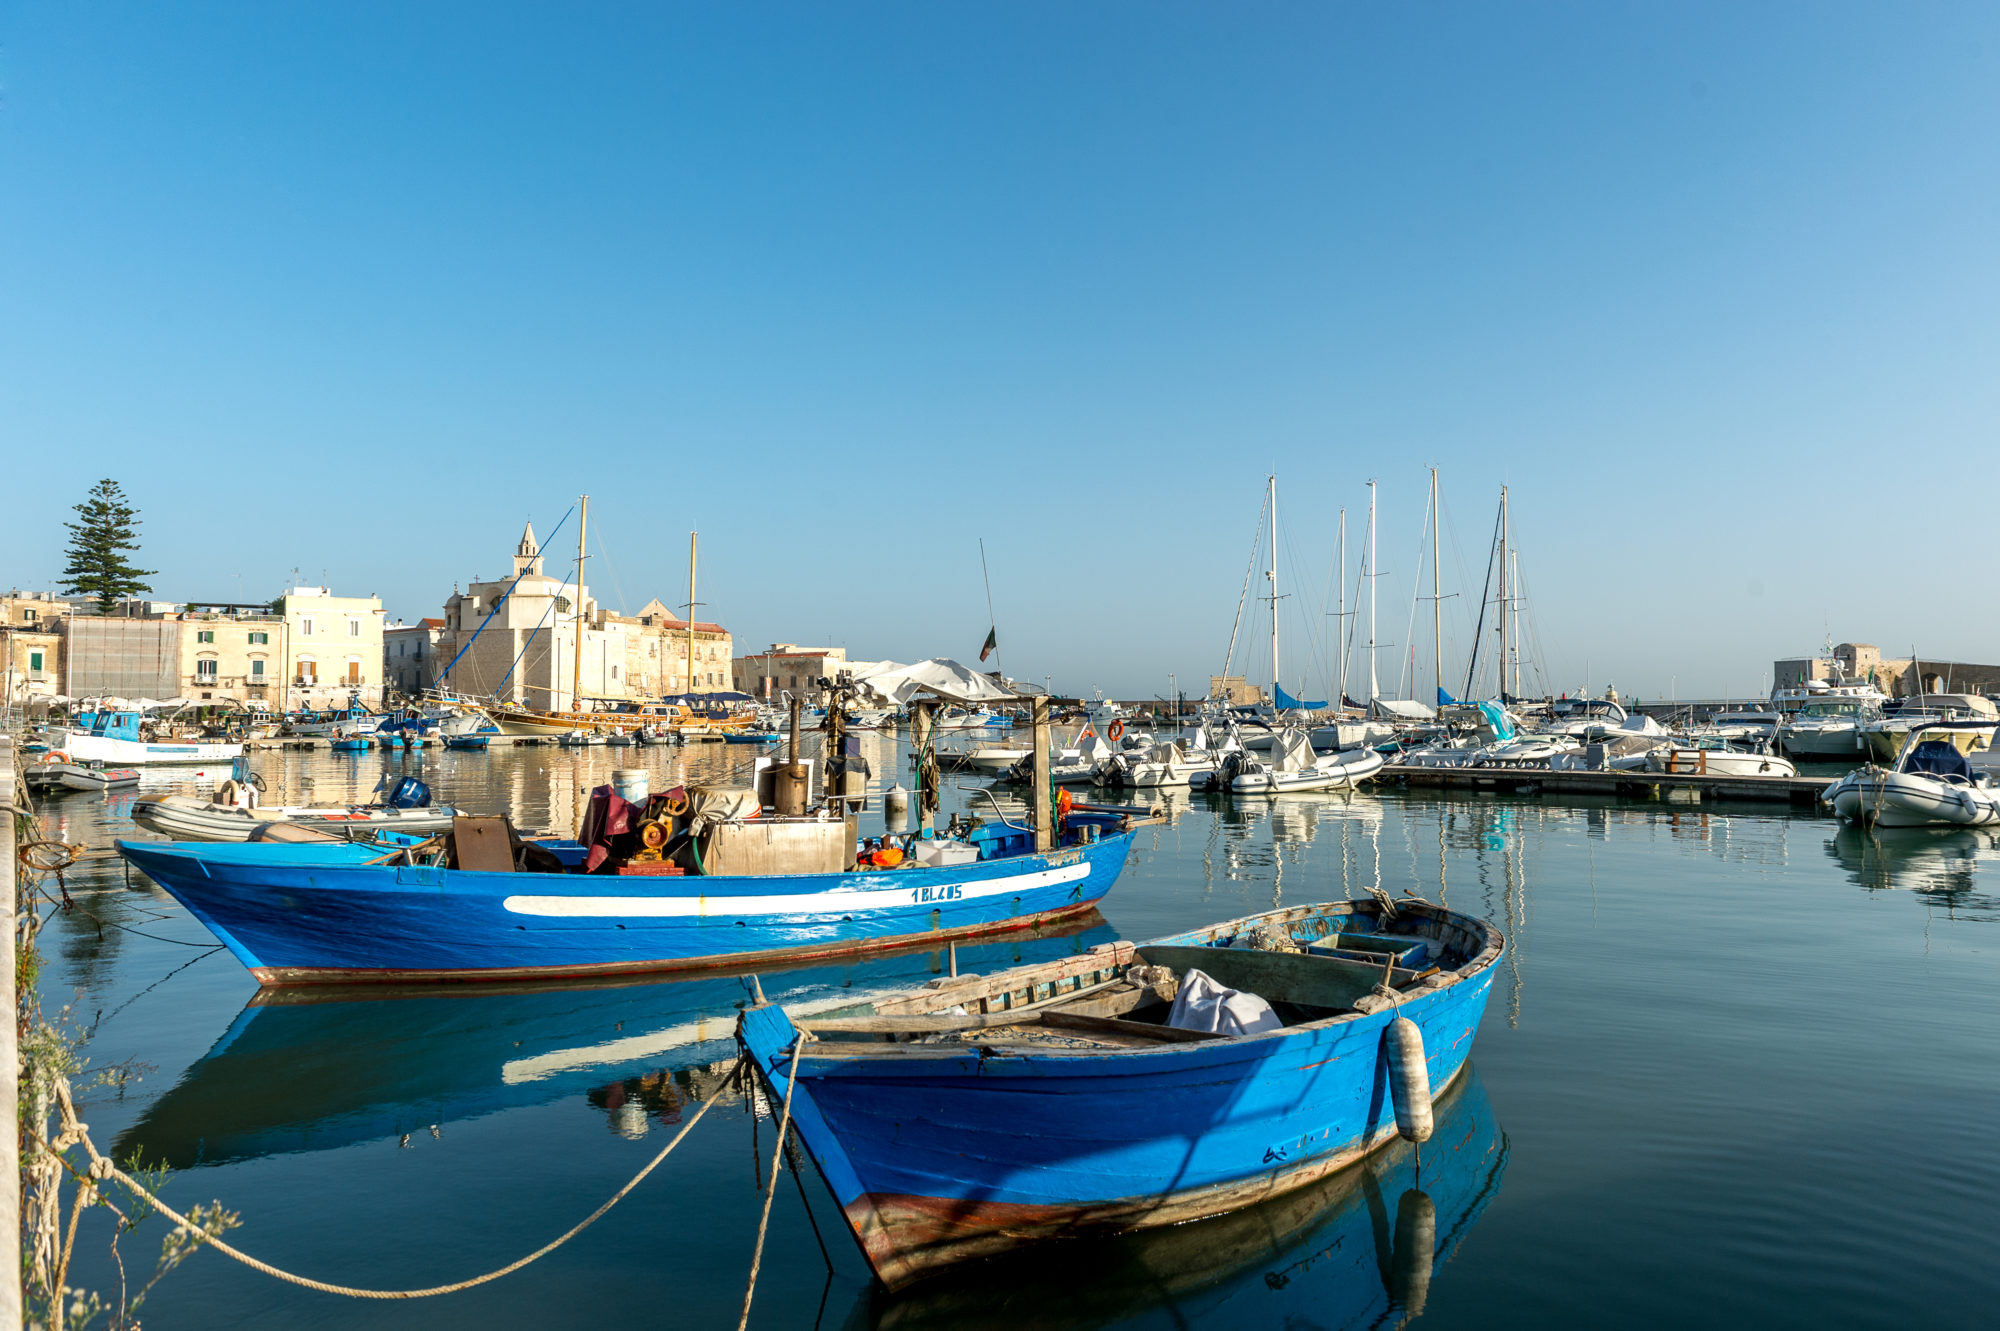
[{"x1": 742, "y1": 901, "x2": 1504, "y2": 1289}]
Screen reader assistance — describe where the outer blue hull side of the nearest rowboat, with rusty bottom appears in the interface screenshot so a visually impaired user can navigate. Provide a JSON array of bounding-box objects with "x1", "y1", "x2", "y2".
[{"x1": 742, "y1": 903, "x2": 1504, "y2": 1289}]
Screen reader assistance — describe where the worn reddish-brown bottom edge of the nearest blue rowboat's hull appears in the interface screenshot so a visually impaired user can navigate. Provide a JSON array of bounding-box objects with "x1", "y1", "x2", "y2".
[{"x1": 846, "y1": 1057, "x2": 1472, "y2": 1291}]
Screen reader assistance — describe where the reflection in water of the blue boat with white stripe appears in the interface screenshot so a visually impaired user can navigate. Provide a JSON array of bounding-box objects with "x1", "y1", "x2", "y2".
[{"x1": 116, "y1": 911, "x2": 1116, "y2": 1169}]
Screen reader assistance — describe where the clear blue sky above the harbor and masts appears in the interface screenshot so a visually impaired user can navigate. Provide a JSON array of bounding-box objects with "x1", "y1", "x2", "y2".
[{"x1": 0, "y1": 2, "x2": 2000, "y2": 695}]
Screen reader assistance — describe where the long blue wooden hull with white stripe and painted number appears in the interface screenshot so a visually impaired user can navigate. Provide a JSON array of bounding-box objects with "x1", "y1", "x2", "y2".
[{"x1": 118, "y1": 813, "x2": 1132, "y2": 985}]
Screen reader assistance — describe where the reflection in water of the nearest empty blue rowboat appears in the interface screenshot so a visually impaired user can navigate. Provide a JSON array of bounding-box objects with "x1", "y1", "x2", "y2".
[{"x1": 848, "y1": 1069, "x2": 1508, "y2": 1331}]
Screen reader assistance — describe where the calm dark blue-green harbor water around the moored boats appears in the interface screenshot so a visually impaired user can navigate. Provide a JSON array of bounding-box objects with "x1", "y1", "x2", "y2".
[{"x1": 27, "y1": 737, "x2": 2000, "y2": 1331}]
